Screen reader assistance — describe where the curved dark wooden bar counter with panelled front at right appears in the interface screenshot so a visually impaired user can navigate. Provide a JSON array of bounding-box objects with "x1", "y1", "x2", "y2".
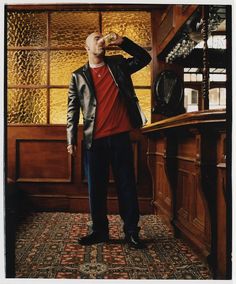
[{"x1": 142, "y1": 110, "x2": 230, "y2": 279}]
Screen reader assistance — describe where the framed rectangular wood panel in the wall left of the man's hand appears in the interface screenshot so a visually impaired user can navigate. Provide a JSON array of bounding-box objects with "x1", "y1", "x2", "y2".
[{"x1": 16, "y1": 139, "x2": 72, "y2": 182}]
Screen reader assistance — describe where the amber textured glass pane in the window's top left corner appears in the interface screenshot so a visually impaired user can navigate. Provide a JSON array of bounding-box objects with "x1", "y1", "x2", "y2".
[{"x1": 7, "y1": 12, "x2": 47, "y2": 46}]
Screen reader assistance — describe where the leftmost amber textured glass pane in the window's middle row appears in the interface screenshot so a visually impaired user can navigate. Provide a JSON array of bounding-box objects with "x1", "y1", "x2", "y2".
[{"x1": 8, "y1": 50, "x2": 47, "y2": 85}]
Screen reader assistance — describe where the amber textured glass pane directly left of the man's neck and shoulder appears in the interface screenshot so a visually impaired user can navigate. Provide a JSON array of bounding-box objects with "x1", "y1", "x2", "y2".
[{"x1": 50, "y1": 50, "x2": 88, "y2": 85}]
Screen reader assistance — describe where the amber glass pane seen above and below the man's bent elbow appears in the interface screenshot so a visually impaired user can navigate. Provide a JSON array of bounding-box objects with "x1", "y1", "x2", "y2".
[{"x1": 106, "y1": 50, "x2": 151, "y2": 86}]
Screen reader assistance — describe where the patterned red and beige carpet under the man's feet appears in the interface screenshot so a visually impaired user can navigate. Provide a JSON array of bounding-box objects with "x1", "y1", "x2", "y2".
[{"x1": 16, "y1": 212, "x2": 212, "y2": 279}]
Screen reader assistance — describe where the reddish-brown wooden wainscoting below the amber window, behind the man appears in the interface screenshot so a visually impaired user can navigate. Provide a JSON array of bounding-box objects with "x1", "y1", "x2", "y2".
[{"x1": 7, "y1": 125, "x2": 152, "y2": 214}]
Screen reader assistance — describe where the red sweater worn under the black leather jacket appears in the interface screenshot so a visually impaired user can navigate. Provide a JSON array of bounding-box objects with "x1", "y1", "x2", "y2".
[{"x1": 90, "y1": 65, "x2": 132, "y2": 139}]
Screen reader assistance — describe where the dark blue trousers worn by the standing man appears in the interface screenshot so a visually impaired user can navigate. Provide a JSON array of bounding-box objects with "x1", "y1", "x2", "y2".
[{"x1": 85, "y1": 132, "x2": 139, "y2": 234}]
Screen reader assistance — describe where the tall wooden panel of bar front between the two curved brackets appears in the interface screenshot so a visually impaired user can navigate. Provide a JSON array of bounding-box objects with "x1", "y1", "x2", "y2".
[{"x1": 174, "y1": 155, "x2": 211, "y2": 256}]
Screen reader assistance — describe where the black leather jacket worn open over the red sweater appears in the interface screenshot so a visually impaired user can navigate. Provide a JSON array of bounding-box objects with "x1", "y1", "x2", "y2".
[{"x1": 67, "y1": 37, "x2": 151, "y2": 149}]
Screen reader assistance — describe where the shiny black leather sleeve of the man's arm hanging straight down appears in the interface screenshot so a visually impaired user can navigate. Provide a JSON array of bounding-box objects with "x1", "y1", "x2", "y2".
[{"x1": 67, "y1": 74, "x2": 80, "y2": 145}]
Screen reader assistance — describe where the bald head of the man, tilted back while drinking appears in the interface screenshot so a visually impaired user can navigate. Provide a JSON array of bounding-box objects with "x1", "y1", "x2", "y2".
[{"x1": 85, "y1": 32, "x2": 105, "y2": 56}]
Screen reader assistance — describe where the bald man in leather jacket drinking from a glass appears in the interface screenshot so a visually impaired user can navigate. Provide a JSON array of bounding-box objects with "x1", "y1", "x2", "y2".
[{"x1": 67, "y1": 32, "x2": 151, "y2": 248}]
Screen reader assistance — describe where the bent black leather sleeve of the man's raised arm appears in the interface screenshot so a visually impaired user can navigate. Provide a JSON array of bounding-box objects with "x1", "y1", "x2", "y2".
[{"x1": 120, "y1": 37, "x2": 152, "y2": 74}]
